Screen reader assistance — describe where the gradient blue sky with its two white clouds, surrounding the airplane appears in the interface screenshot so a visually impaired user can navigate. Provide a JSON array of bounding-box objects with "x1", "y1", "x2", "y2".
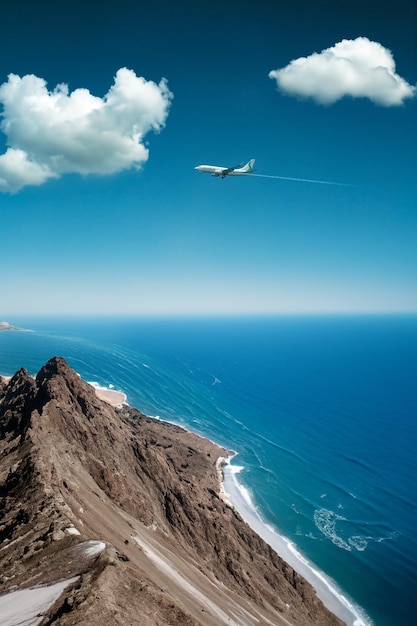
[{"x1": 0, "y1": 0, "x2": 417, "y2": 312}]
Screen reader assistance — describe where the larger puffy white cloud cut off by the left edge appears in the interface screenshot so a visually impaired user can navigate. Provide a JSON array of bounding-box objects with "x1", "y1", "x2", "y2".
[{"x1": 0, "y1": 68, "x2": 173, "y2": 192}]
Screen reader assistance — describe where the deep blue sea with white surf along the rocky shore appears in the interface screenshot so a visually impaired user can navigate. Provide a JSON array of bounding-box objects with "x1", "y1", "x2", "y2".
[{"x1": 0, "y1": 315, "x2": 417, "y2": 626}]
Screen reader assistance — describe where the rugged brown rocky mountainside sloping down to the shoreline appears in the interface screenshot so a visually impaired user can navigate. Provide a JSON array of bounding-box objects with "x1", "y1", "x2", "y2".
[{"x1": 0, "y1": 358, "x2": 341, "y2": 626}]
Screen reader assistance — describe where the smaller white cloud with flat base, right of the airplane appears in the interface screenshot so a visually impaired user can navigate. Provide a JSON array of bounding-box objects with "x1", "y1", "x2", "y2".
[{"x1": 269, "y1": 37, "x2": 416, "y2": 106}]
